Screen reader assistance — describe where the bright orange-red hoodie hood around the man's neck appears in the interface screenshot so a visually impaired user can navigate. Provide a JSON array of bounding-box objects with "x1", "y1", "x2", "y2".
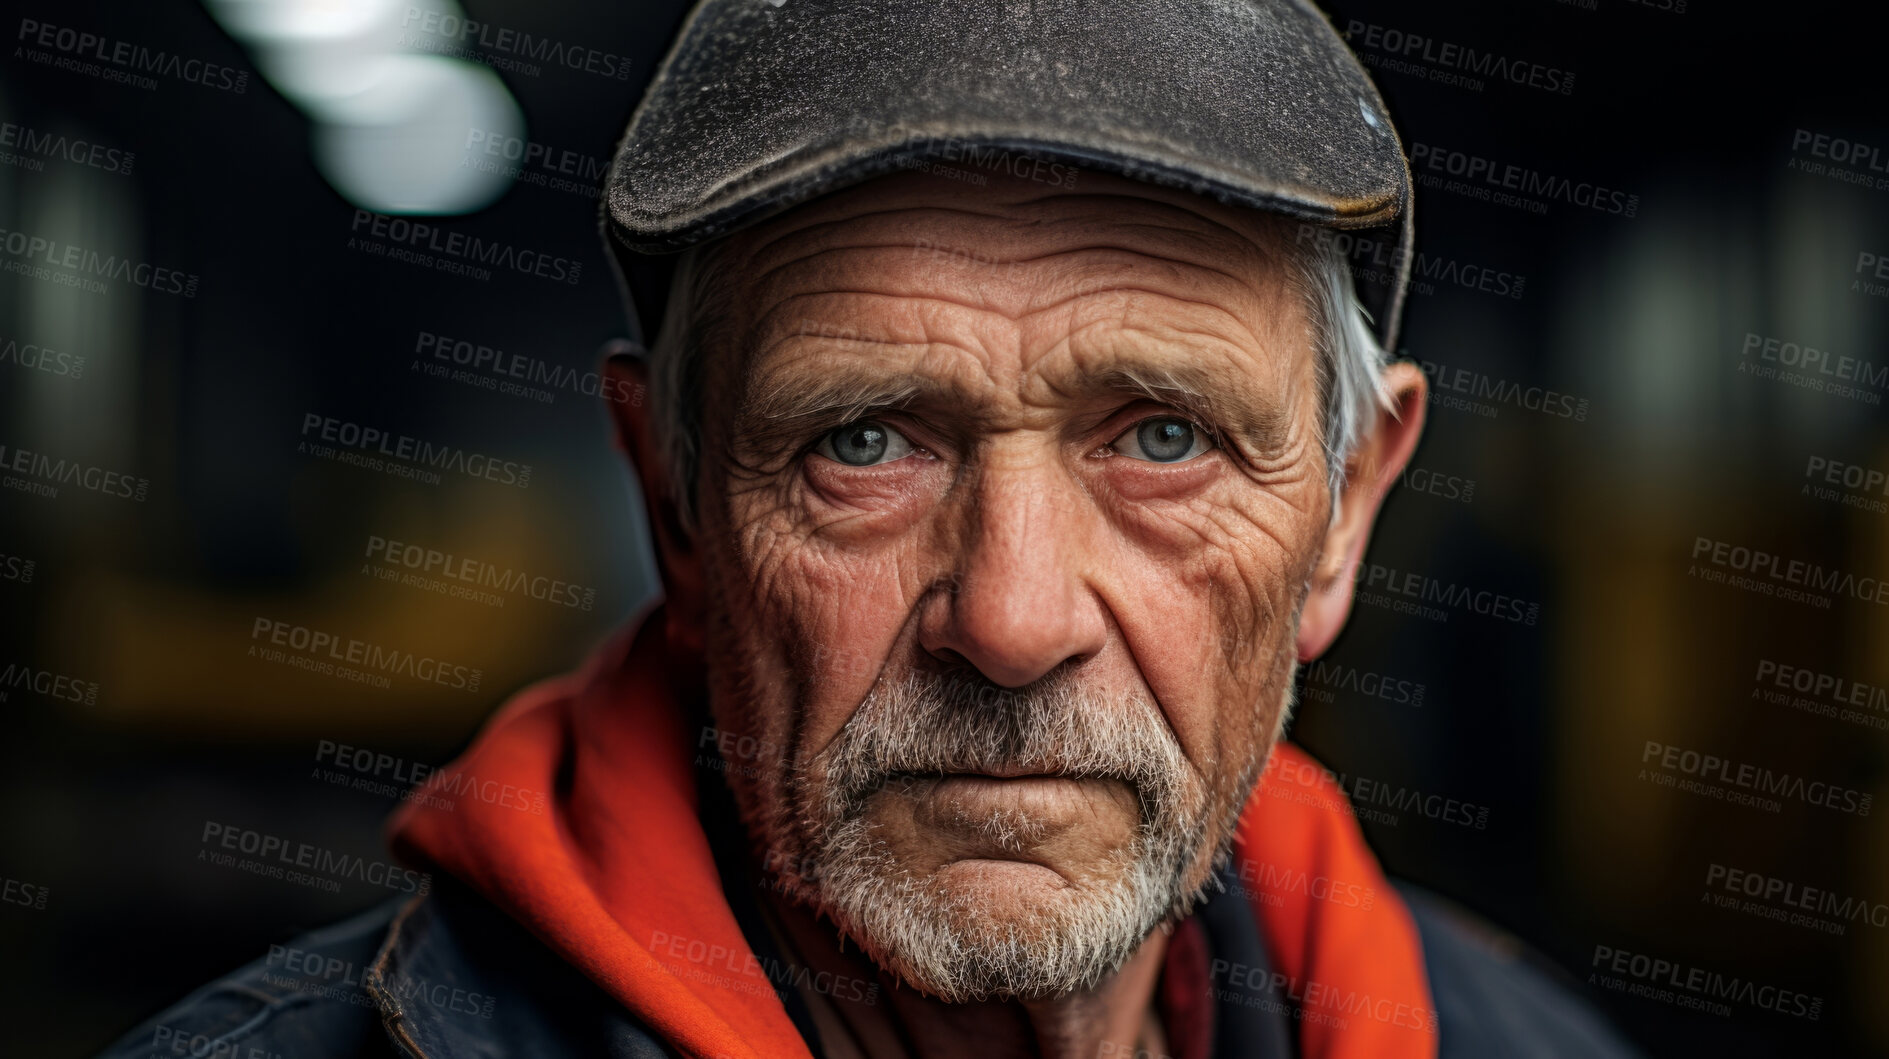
[{"x1": 389, "y1": 610, "x2": 1436, "y2": 1059}]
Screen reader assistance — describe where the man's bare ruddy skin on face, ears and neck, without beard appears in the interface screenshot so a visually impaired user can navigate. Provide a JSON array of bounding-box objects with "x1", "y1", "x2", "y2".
[{"x1": 612, "y1": 174, "x2": 1424, "y2": 1059}]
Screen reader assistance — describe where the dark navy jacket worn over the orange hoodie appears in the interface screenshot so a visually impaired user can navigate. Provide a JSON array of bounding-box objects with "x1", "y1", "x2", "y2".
[{"x1": 104, "y1": 882, "x2": 1634, "y2": 1059}]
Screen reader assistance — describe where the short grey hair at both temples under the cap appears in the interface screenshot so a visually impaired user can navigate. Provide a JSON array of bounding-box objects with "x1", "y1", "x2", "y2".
[{"x1": 650, "y1": 231, "x2": 1390, "y2": 529}]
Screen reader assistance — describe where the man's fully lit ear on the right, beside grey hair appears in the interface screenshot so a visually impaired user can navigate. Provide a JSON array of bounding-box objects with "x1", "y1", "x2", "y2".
[{"x1": 1298, "y1": 361, "x2": 1430, "y2": 663}]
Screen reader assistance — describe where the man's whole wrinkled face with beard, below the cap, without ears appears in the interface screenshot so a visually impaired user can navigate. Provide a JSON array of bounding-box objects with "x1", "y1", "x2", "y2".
[{"x1": 695, "y1": 174, "x2": 1330, "y2": 1000}]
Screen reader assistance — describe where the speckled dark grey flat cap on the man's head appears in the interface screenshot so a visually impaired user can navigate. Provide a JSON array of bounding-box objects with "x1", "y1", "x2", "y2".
[{"x1": 604, "y1": 0, "x2": 1411, "y2": 347}]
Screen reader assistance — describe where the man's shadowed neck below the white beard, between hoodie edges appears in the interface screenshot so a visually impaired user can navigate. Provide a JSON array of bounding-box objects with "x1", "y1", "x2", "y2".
[{"x1": 761, "y1": 889, "x2": 1167, "y2": 1059}]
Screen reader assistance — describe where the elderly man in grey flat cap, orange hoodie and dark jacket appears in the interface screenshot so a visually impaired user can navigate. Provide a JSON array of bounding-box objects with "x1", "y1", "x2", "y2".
[{"x1": 107, "y1": 0, "x2": 1619, "y2": 1059}]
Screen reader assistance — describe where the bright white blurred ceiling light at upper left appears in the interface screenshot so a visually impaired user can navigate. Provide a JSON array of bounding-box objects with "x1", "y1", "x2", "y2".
[{"x1": 204, "y1": 0, "x2": 525, "y2": 215}]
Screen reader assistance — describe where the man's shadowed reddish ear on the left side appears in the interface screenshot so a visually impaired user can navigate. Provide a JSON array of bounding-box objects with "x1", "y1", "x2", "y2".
[{"x1": 603, "y1": 342, "x2": 703, "y2": 651}]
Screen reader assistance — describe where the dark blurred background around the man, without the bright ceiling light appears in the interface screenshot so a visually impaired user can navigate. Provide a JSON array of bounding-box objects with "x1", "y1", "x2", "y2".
[{"x1": 0, "y1": 0, "x2": 1889, "y2": 1055}]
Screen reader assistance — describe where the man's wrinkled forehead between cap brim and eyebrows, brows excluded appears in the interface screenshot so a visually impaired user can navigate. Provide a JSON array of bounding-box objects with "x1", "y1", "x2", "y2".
[{"x1": 722, "y1": 170, "x2": 1307, "y2": 386}]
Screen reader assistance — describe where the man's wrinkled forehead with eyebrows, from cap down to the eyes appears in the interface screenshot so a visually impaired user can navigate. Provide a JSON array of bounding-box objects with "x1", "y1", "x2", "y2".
[{"x1": 695, "y1": 172, "x2": 1317, "y2": 462}]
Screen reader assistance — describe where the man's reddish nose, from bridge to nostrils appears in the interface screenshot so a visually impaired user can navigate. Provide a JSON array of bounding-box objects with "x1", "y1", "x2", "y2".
[{"x1": 918, "y1": 466, "x2": 1109, "y2": 687}]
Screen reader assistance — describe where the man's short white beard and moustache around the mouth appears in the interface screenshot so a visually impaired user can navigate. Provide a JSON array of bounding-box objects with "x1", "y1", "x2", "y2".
[{"x1": 765, "y1": 674, "x2": 1292, "y2": 1002}]
